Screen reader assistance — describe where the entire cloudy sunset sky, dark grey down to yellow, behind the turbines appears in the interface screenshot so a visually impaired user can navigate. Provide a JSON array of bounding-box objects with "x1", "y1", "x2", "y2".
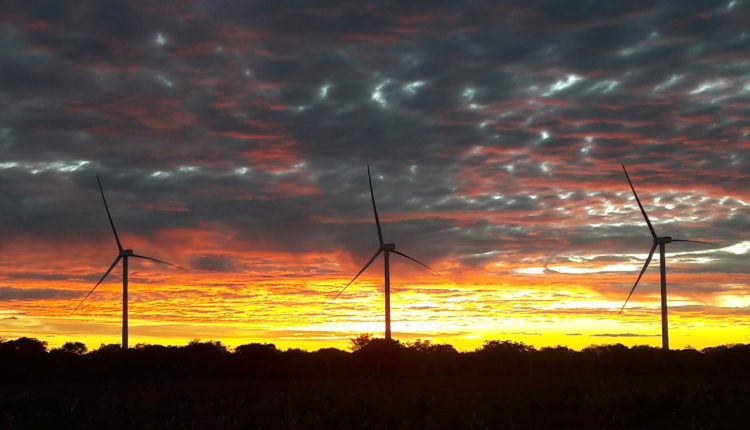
[{"x1": 0, "y1": 0, "x2": 750, "y2": 350}]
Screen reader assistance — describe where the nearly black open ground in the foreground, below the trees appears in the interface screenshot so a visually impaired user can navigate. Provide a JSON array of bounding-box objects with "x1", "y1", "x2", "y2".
[{"x1": 0, "y1": 369, "x2": 750, "y2": 429}]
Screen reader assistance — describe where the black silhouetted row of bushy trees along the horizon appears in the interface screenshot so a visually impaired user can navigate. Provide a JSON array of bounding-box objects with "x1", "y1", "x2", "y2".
[{"x1": 0, "y1": 334, "x2": 750, "y2": 382}]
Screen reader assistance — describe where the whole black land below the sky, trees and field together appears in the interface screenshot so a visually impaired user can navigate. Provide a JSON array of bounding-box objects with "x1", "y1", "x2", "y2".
[{"x1": 0, "y1": 340, "x2": 750, "y2": 429}]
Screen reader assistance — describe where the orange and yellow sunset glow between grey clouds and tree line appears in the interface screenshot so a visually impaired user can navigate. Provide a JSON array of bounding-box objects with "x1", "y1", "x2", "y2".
[{"x1": 0, "y1": 239, "x2": 750, "y2": 351}]
